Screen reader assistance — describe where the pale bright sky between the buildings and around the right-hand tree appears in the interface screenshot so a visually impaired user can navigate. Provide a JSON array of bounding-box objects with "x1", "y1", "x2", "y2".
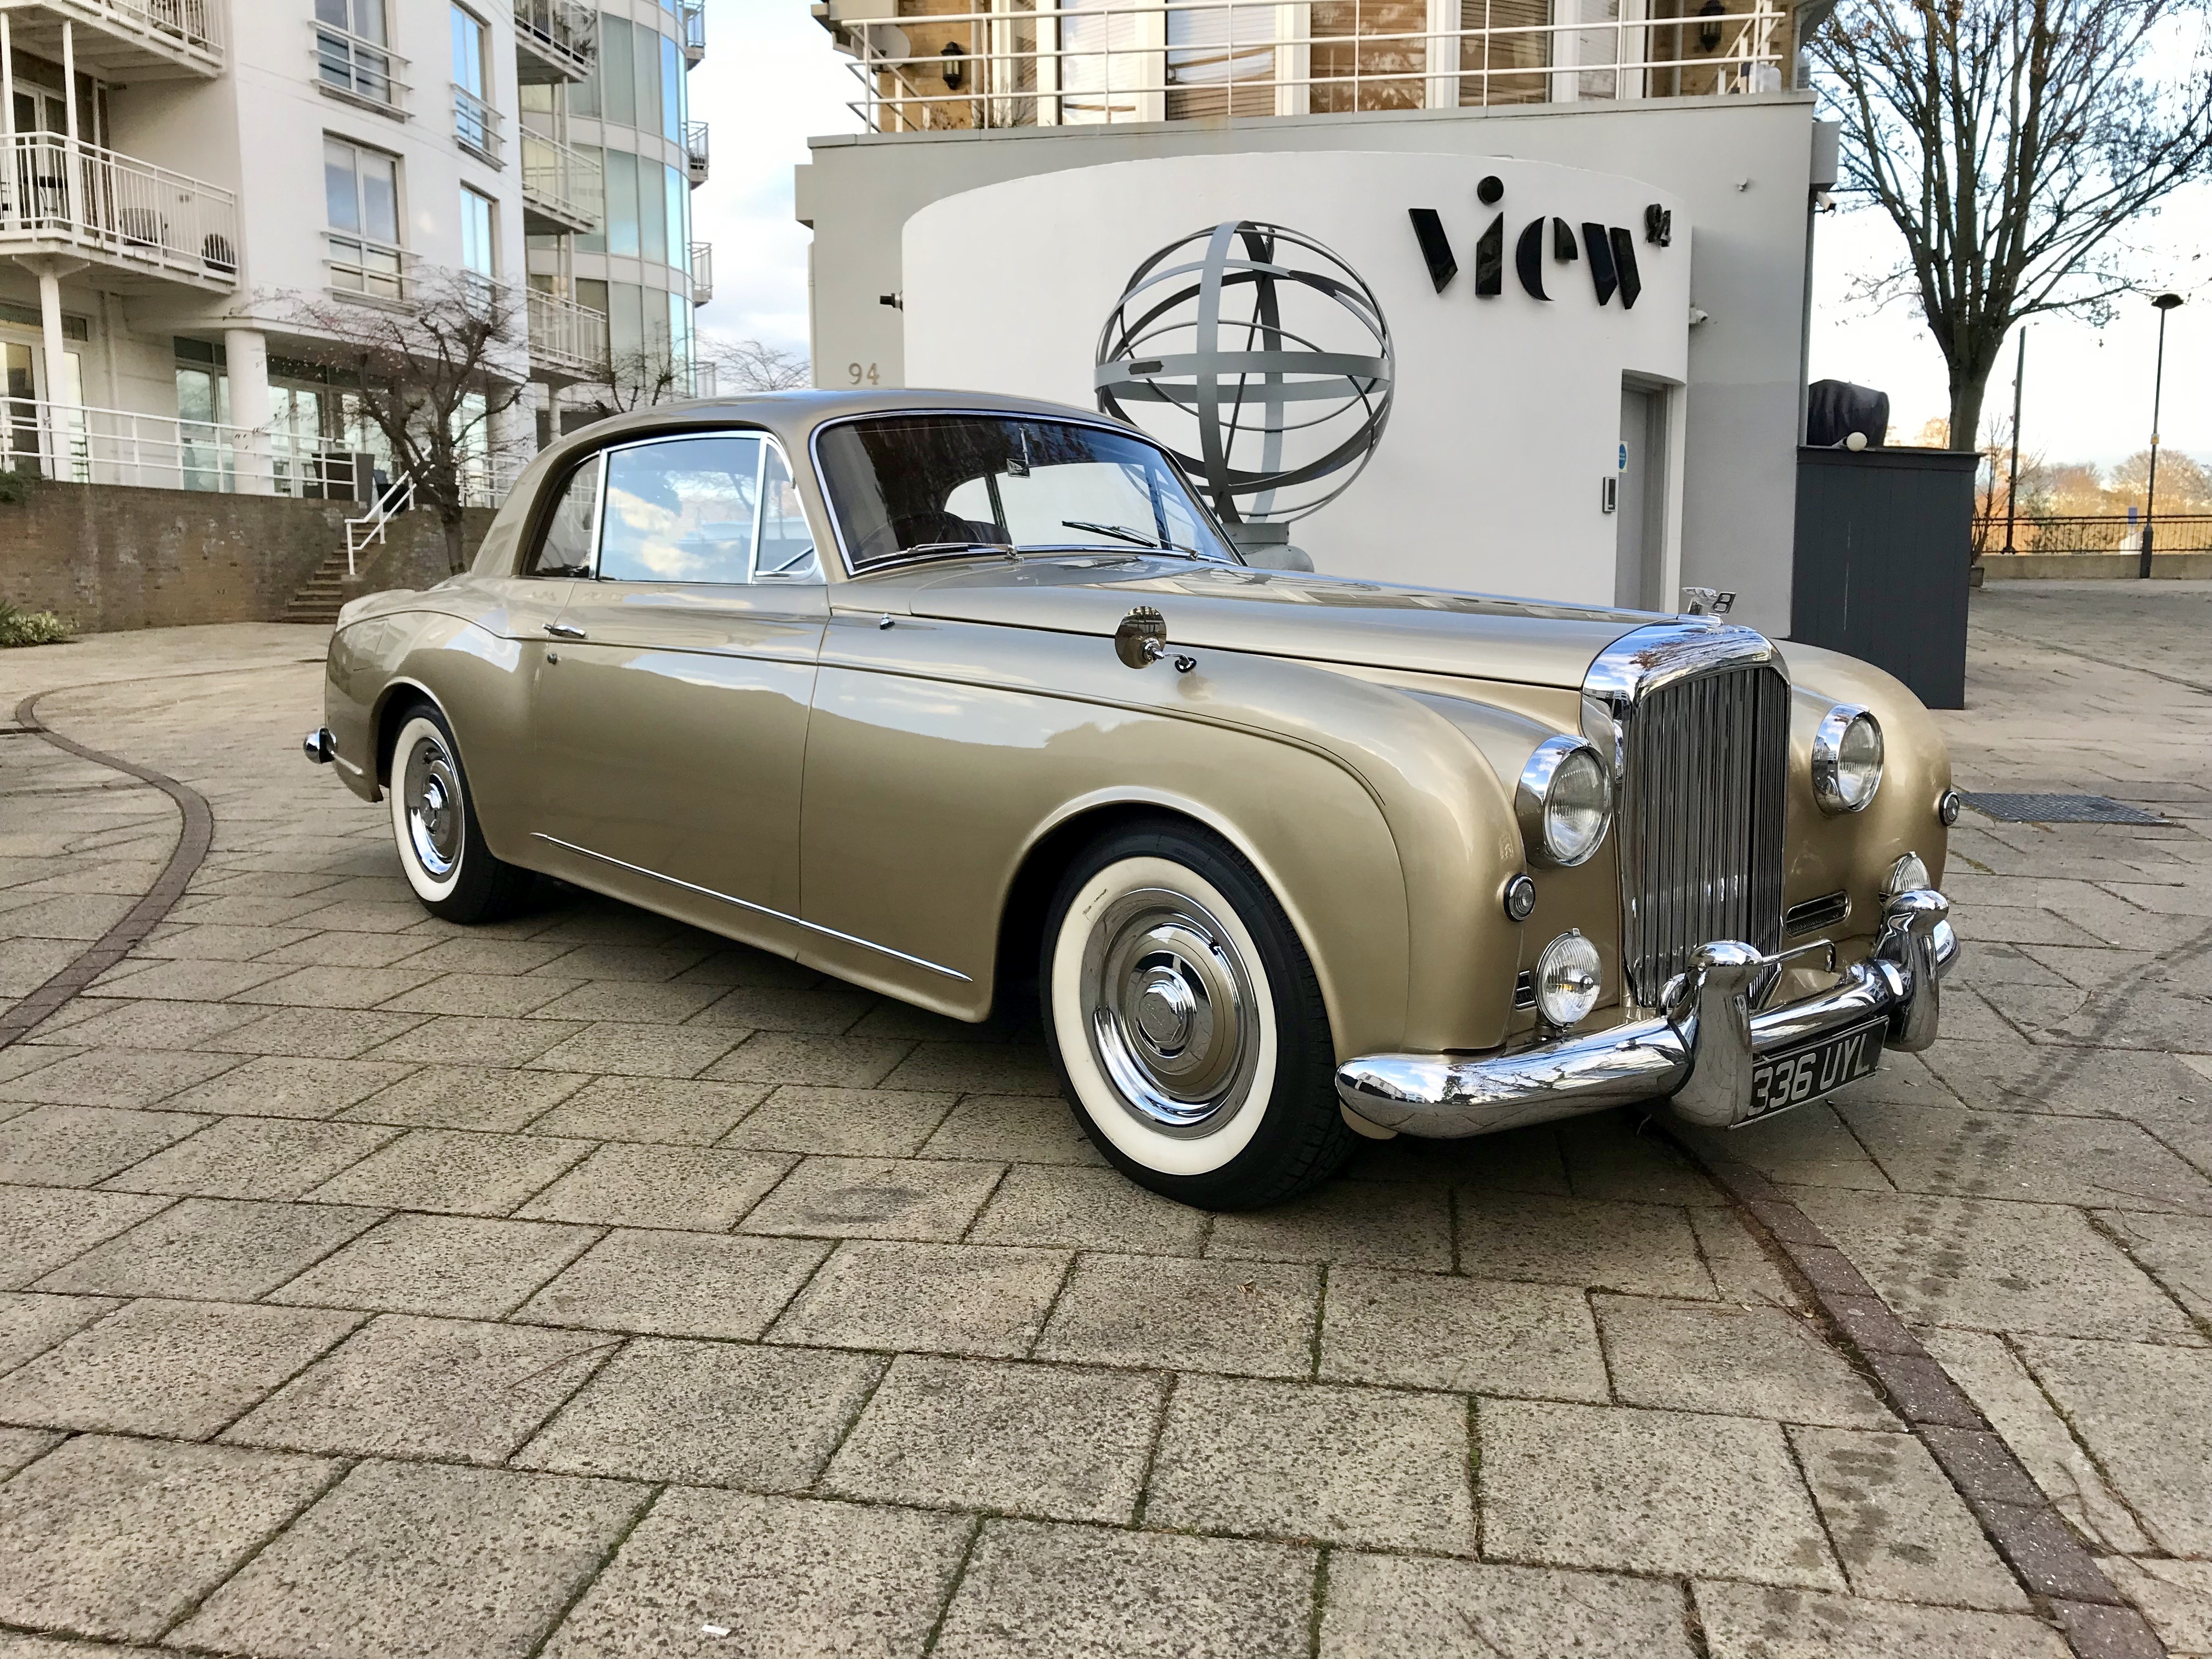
[{"x1": 692, "y1": 0, "x2": 2212, "y2": 465}]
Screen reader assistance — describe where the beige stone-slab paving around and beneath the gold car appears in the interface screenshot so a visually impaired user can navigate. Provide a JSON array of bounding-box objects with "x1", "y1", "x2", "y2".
[{"x1": 0, "y1": 584, "x2": 2212, "y2": 1659}]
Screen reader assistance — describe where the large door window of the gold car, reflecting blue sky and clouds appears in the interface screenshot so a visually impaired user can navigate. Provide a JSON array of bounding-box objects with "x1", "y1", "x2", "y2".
[{"x1": 600, "y1": 433, "x2": 763, "y2": 582}]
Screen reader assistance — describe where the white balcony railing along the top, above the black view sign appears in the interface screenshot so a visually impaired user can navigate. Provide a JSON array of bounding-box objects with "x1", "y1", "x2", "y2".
[{"x1": 840, "y1": 0, "x2": 1792, "y2": 133}]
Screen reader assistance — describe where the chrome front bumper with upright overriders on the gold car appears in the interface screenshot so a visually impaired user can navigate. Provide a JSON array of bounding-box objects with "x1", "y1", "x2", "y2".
[{"x1": 1336, "y1": 889, "x2": 1957, "y2": 1139}]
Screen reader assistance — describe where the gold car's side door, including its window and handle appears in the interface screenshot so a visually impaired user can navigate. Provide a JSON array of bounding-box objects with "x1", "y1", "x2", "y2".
[{"x1": 533, "y1": 429, "x2": 827, "y2": 949}]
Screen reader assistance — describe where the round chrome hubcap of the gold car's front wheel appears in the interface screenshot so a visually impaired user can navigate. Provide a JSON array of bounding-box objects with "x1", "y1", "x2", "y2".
[{"x1": 1082, "y1": 887, "x2": 1259, "y2": 1137}]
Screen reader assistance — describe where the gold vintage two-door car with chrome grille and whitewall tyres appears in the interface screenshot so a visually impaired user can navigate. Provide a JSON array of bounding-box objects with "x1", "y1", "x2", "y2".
[{"x1": 307, "y1": 392, "x2": 1957, "y2": 1207}]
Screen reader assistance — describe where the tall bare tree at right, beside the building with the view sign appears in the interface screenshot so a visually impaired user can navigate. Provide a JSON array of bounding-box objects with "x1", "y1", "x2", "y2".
[{"x1": 1807, "y1": 0, "x2": 2212, "y2": 449}]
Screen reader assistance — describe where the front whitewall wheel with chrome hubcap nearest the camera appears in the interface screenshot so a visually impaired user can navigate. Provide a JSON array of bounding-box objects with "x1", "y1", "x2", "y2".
[{"x1": 1040, "y1": 825, "x2": 1358, "y2": 1210}]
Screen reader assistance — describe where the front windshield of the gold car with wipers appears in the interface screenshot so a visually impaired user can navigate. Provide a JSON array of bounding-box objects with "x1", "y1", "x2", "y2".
[{"x1": 816, "y1": 414, "x2": 1237, "y2": 571}]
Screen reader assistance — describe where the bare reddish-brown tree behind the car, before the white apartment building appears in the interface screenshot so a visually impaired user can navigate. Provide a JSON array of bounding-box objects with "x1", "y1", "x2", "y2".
[{"x1": 287, "y1": 268, "x2": 529, "y2": 571}]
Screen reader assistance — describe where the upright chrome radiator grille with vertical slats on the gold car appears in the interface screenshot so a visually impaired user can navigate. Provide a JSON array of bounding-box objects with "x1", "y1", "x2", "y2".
[{"x1": 1615, "y1": 664, "x2": 1790, "y2": 1007}]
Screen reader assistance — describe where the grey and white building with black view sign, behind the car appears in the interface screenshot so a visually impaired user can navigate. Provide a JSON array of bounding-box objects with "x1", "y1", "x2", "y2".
[{"x1": 797, "y1": 0, "x2": 1834, "y2": 630}]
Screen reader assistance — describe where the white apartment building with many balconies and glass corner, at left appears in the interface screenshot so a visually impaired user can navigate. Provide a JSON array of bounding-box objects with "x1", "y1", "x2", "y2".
[{"x1": 0, "y1": 0, "x2": 706, "y2": 500}]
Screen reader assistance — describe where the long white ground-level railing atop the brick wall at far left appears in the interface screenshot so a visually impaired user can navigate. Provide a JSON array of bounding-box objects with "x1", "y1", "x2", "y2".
[{"x1": 0, "y1": 398, "x2": 354, "y2": 500}]
